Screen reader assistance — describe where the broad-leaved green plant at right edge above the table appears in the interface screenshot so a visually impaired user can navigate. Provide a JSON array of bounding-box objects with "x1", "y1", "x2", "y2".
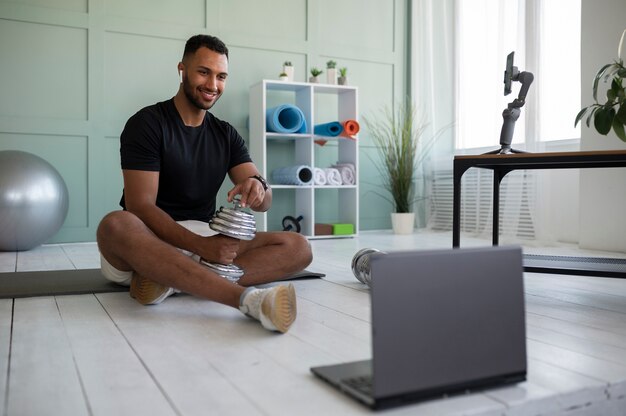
[{"x1": 574, "y1": 30, "x2": 626, "y2": 142}]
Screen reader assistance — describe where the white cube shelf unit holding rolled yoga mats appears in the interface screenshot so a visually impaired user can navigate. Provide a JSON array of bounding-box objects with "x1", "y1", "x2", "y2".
[{"x1": 249, "y1": 80, "x2": 359, "y2": 238}]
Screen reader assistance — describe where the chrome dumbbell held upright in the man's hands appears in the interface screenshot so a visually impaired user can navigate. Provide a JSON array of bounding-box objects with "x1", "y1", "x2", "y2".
[{"x1": 200, "y1": 198, "x2": 256, "y2": 283}]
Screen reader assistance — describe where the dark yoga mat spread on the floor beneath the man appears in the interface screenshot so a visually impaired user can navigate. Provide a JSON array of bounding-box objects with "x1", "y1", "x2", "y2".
[{"x1": 0, "y1": 269, "x2": 325, "y2": 299}]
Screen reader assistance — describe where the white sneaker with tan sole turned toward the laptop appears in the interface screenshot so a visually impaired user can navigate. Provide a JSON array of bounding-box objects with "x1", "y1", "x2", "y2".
[{"x1": 239, "y1": 283, "x2": 297, "y2": 333}]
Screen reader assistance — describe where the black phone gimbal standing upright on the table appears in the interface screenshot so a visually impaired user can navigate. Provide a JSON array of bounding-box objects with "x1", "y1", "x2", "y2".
[{"x1": 485, "y1": 52, "x2": 535, "y2": 155}]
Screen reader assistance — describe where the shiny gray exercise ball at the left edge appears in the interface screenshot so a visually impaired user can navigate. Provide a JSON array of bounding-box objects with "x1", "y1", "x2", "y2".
[{"x1": 0, "y1": 150, "x2": 69, "y2": 251}]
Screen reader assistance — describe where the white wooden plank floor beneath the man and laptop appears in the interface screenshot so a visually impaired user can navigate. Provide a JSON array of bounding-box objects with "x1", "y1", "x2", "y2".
[{"x1": 0, "y1": 232, "x2": 626, "y2": 416}]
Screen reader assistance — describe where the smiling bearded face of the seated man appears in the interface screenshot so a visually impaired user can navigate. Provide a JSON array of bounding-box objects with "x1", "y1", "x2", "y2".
[{"x1": 183, "y1": 47, "x2": 228, "y2": 110}]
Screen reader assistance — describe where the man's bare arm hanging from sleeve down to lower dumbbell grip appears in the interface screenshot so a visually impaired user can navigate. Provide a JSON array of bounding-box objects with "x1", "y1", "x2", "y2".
[{"x1": 122, "y1": 169, "x2": 239, "y2": 264}]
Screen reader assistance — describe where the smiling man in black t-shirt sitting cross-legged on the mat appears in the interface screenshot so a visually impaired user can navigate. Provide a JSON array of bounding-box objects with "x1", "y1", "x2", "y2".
[{"x1": 97, "y1": 35, "x2": 312, "y2": 332}]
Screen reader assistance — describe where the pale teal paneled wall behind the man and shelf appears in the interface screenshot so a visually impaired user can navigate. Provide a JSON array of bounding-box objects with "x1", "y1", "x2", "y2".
[{"x1": 0, "y1": 0, "x2": 408, "y2": 242}]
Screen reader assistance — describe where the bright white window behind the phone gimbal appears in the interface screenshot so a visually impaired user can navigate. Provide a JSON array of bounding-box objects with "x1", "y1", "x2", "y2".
[{"x1": 455, "y1": 0, "x2": 581, "y2": 150}]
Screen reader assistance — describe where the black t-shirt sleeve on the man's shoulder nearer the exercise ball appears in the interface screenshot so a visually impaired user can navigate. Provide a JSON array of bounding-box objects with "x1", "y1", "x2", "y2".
[{"x1": 120, "y1": 109, "x2": 162, "y2": 171}]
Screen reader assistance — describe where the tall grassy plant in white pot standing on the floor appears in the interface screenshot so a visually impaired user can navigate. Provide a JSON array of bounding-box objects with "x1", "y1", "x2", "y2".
[{"x1": 364, "y1": 99, "x2": 427, "y2": 234}]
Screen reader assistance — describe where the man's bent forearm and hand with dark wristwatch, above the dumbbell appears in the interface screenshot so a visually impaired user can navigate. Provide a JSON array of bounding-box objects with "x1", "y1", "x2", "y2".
[{"x1": 228, "y1": 162, "x2": 272, "y2": 212}]
